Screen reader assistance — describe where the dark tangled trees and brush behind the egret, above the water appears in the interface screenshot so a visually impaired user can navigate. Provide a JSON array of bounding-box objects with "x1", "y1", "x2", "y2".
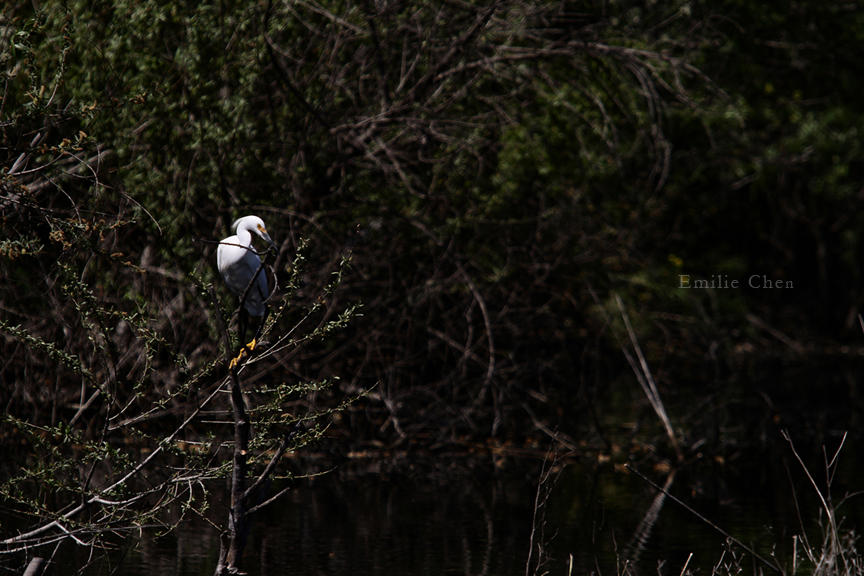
[{"x1": 0, "y1": 0, "x2": 864, "y2": 572}]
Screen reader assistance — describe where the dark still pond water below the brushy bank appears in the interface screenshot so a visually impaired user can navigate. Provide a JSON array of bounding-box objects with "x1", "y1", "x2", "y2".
[{"x1": 6, "y1": 362, "x2": 864, "y2": 576}]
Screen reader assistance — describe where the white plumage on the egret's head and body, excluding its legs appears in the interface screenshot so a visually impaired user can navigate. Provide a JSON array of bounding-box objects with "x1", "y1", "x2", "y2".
[{"x1": 216, "y1": 216, "x2": 273, "y2": 317}]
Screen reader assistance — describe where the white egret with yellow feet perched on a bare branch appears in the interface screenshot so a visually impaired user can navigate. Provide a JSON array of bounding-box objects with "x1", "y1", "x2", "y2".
[{"x1": 216, "y1": 216, "x2": 276, "y2": 369}]
